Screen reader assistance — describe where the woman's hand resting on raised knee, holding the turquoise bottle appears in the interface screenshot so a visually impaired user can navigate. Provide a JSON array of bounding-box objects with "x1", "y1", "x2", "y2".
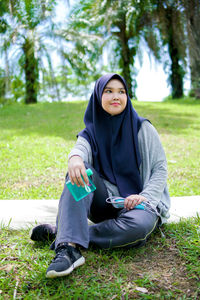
[{"x1": 68, "y1": 155, "x2": 89, "y2": 187}]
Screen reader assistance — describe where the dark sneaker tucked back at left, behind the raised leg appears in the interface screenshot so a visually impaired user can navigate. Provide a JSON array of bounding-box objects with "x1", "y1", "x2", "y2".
[{"x1": 30, "y1": 224, "x2": 57, "y2": 242}]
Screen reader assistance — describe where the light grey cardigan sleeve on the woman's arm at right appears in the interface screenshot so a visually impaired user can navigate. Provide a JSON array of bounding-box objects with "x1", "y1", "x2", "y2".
[{"x1": 138, "y1": 121, "x2": 167, "y2": 206}]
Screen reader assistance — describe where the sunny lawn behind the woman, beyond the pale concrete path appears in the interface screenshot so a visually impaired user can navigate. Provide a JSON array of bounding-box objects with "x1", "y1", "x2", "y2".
[{"x1": 0, "y1": 100, "x2": 200, "y2": 199}]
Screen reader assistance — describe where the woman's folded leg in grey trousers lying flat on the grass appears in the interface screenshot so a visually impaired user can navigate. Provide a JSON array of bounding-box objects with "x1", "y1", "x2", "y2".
[{"x1": 89, "y1": 209, "x2": 159, "y2": 249}]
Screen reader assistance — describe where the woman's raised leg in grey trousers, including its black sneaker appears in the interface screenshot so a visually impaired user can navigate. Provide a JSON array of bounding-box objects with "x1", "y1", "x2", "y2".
[{"x1": 46, "y1": 166, "x2": 122, "y2": 278}]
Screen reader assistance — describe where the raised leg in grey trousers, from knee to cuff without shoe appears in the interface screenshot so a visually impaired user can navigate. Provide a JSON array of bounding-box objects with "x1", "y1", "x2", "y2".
[{"x1": 55, "y1": 163, "x2": 118, "y2": 248}]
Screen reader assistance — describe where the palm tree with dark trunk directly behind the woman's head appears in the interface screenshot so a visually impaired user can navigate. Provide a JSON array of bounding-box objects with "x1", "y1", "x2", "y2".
[{"x1": 94, "y1": 0, "x2": 156, "y2": 98}]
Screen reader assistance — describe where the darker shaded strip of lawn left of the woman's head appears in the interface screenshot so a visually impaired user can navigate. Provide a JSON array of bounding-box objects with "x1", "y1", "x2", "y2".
[{"x1": 0, "y1": 102, "x2": 87, "y2": 140}]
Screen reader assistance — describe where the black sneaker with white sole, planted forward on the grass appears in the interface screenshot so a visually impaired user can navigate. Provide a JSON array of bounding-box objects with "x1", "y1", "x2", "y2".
[{"x1": 46, "y1": 243, "x2": 85, "y2": 278}]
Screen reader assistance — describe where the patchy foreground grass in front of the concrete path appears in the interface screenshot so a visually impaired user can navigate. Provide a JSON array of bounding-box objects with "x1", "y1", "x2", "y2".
[{"x1": 0, "y1": 217, "x2": 200, "y2": 300}]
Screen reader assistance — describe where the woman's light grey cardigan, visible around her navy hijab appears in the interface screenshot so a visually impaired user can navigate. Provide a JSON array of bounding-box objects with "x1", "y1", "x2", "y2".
[{"x1": 68, "y1": 121, "x2": 170, "y2": 223}]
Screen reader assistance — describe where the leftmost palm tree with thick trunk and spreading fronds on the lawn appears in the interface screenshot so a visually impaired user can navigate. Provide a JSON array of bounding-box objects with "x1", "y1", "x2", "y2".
[{"x1": 2, "y1": 0, "x2": 55, "y2": 104}]
